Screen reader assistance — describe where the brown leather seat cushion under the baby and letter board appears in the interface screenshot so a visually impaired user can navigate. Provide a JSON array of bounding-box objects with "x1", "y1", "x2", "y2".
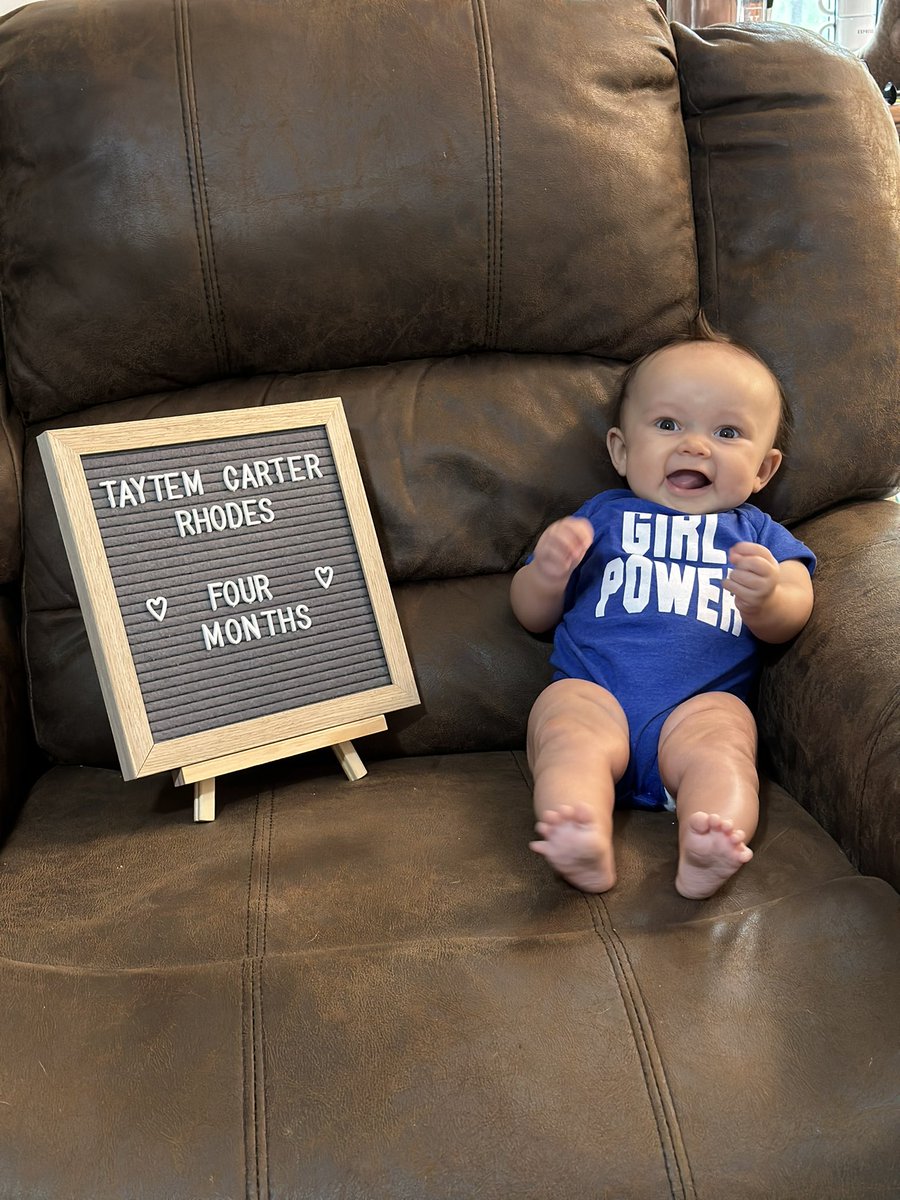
[{"x1": 0, "y1": 744, "x2": 900, "y2": 1200}]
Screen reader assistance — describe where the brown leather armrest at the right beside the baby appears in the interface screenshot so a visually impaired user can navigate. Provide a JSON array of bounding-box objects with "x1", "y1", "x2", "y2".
[{"x1": 758, "y1": 500, "x2": 900, "y2": 888}]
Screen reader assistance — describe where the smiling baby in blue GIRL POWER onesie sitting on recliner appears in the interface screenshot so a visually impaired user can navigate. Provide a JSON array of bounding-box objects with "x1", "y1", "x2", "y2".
[{"x1": 510, "y1": 325, "x2": 816, "y2": 899}]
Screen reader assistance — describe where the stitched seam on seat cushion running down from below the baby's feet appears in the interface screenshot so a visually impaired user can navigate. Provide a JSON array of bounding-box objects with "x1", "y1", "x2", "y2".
[{"x1": 584, "y1": 895, "x2": 697, "y2": 1200}]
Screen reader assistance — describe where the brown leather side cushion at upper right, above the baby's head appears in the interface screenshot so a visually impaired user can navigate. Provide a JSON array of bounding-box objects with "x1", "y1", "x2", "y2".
[{"x1": 673, "y1": 25, "x2": 900, "y2": 521}]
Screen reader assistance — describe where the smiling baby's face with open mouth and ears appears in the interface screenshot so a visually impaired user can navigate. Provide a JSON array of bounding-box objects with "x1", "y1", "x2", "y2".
[{"x1": 607, "y1": 342, "x2": 781, "y2": 514}]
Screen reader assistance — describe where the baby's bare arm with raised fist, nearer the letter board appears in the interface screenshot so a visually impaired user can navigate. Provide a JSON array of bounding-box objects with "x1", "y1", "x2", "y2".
[{"x1": 510, "y1": 517, "x2": 594, "y2": 634}]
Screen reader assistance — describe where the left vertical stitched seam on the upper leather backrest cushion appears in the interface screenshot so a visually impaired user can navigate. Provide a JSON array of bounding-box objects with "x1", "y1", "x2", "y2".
[{"x1": 175, "y1": 0, "x2": 229, "y2": 374}]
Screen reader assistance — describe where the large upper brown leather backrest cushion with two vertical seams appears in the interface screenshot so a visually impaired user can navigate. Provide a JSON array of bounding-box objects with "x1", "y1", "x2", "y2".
[{"x1": 0, "y1": 0, "x2": 697, "y2": 421}]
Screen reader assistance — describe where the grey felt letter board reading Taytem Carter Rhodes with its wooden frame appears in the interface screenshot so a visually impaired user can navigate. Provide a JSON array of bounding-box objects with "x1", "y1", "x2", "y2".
[{"x1": 38, "y1": 398, "x2": 418, "y2": 779}]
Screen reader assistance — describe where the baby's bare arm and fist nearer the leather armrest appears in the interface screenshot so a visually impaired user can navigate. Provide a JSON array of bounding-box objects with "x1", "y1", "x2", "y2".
[{"x1": 722, "y1": 541, "x2": 812, "y2": 643}]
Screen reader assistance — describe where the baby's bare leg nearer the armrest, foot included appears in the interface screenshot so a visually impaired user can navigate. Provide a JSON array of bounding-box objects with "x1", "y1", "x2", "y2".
[{"x1": 659, "y1": 691, "x2": 760, "y2": 900}]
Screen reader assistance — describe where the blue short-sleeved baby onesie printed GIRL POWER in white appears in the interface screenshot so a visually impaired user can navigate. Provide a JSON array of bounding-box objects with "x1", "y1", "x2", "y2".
[{"x1": 551, "y1": 488, "x2": 816, "y2": 809}]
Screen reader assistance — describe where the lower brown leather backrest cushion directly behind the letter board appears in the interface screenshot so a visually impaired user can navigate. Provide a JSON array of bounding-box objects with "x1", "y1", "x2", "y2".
[{"x1": 25, "y1": 354, "x2": 622, "y2": 764}]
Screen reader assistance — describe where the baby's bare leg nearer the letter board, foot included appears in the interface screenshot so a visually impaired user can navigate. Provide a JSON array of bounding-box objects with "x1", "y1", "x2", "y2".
[{"x1": 528, "y1": 679, "x2": 629, "y2": 892}]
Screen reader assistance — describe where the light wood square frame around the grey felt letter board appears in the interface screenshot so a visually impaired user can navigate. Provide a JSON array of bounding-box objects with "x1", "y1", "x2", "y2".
[{"x1": 37, "y1": 397, "x2": 419, "y2": 779}]
